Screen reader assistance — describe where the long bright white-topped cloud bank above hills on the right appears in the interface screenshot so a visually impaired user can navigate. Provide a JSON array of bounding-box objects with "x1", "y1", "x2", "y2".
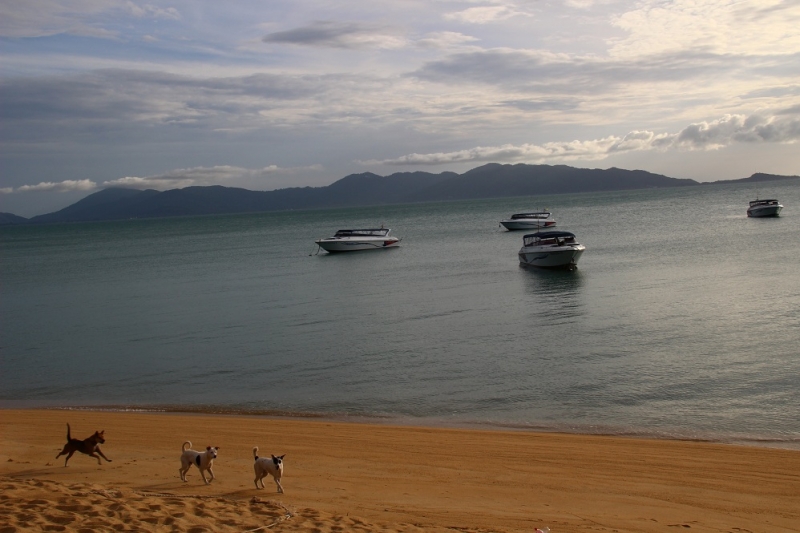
[{"x1": 368, "y1": 114, "x2": 800, "y2": 165}]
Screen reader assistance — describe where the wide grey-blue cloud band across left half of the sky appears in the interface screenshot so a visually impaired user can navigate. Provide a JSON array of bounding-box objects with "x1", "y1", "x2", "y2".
[{"x1": 0, "y1": 69, "x2": 366, "y2": 142}]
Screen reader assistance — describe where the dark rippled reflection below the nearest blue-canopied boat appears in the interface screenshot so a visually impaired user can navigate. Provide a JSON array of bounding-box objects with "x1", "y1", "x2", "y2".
[{"x1": 519, "y1": 265, "x2": 586, "y2": 324}]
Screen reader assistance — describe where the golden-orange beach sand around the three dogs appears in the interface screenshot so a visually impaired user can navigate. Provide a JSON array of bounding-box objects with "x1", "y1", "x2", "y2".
[{"x1": 0, "y1": 409, "x2": 800, "y2": 533}]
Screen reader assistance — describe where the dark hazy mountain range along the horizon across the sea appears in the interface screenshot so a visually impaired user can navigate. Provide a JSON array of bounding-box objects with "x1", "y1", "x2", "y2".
[{"x1": 0, "y1": 163, "x2": 800, "y2": 224}]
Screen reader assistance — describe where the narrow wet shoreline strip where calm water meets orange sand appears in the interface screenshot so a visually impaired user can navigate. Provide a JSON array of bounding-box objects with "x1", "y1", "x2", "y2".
[{"x1": 0, "y1": 402, "x2": 800, "y2": 451}]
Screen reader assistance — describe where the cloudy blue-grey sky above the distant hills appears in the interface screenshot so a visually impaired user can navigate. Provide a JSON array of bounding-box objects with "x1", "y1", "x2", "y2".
[{"x1": 0, "y1": 0, "x2": 800, "y2": 217}]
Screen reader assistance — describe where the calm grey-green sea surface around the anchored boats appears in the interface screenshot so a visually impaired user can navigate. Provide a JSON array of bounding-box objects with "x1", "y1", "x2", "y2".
[{"x1": 0, "y1": 182, "x2": 800, "y2": 449}]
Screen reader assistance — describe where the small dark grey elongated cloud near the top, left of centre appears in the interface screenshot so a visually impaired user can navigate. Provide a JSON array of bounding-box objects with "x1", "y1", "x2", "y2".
[{"x1": 261, "y1": 20, "x2": 406, "y2": 49}]
